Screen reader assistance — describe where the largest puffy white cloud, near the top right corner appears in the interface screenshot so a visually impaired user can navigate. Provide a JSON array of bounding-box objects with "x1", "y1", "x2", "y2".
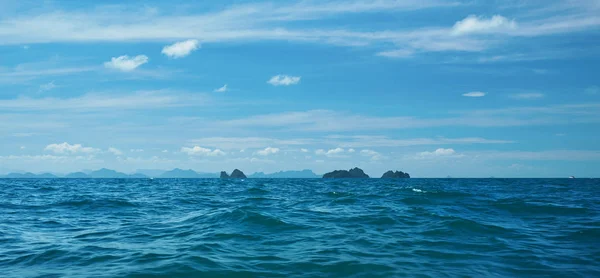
[{"x1": 452, "y1": 15, "x2": 517, "y2": 35}]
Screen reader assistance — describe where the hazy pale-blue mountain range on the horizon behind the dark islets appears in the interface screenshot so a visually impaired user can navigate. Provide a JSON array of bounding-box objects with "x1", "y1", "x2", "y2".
[{"x1": 0, "y1": 168, "x2": 321, "y2": 179}]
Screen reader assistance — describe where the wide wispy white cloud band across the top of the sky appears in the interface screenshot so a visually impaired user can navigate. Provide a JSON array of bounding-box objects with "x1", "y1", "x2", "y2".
[{"x1": 0, "y1": 0, "x2": 600, "y2": 58}]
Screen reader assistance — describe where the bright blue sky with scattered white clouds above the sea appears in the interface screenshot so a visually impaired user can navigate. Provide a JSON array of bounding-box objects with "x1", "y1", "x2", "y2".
[{"x1": 0, "y1": 0, "x2": 600, "y2": 177}]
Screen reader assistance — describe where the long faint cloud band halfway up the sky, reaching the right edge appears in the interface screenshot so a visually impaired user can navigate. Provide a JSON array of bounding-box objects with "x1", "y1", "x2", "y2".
[{"x1": 218, "y1": 105, "x2": 600, "y2": 132}]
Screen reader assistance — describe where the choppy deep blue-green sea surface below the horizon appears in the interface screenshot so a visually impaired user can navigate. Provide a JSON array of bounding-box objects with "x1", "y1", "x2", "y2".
[{"x1": 0, "y1": 179, "x2": 600, "y2": 277}]
